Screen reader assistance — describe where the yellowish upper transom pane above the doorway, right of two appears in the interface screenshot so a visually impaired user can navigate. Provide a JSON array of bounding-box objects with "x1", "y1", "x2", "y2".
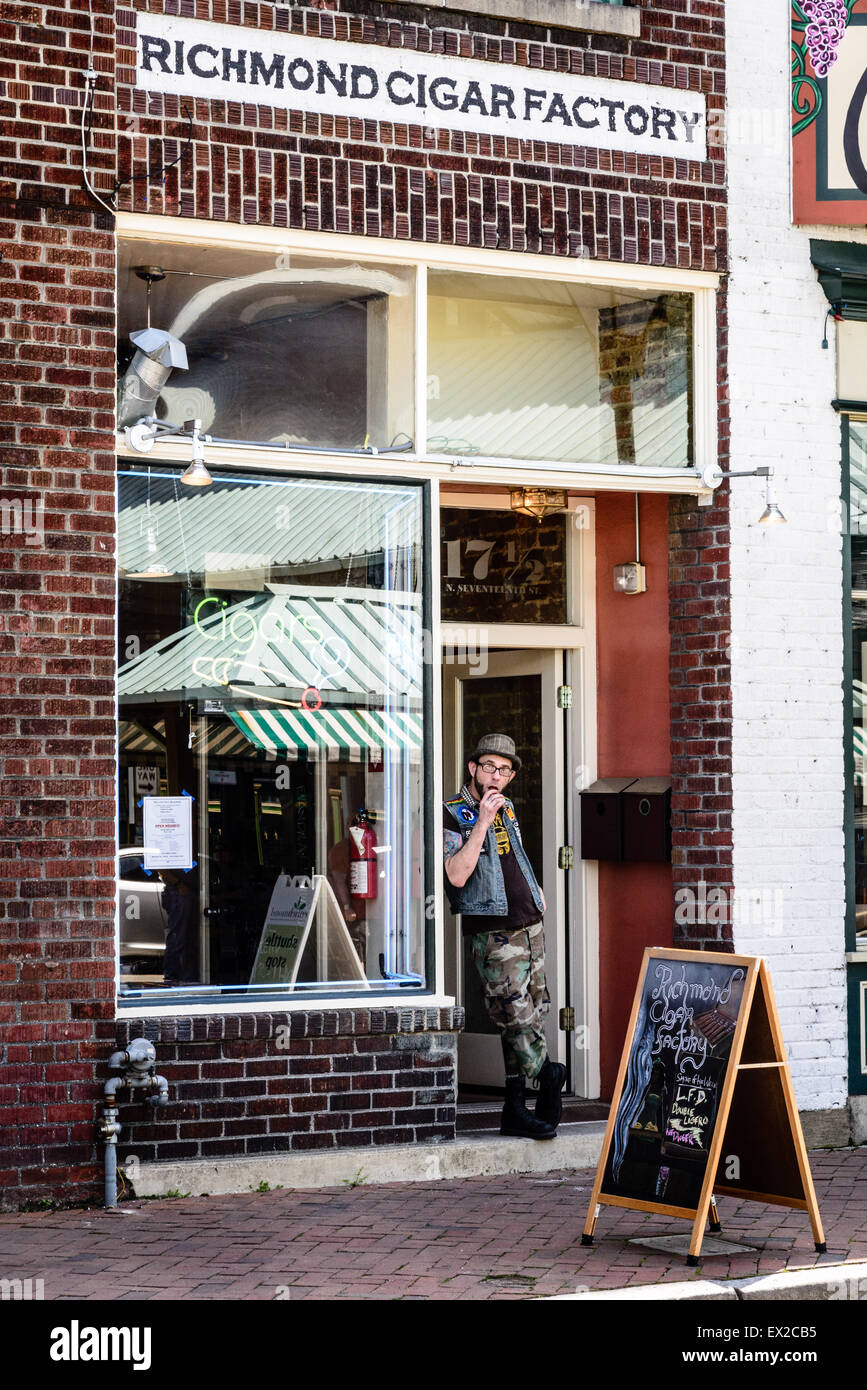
[{"x1": 428, "y1": 271, "x2": 692, "y2": 467}]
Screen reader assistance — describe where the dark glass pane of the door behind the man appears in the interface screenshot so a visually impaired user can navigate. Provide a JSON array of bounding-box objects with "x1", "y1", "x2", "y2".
[{"x1": 461, "y1": 676, "x2": 545, "y2": 1033}]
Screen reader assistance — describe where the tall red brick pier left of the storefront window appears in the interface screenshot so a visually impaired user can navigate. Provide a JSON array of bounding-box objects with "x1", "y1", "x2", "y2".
[{"x1": 0, "y1": 0, "x2": 115, "y2": 1202}]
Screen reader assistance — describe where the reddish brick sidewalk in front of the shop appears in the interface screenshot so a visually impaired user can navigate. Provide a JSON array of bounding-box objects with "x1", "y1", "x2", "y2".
[{"x1": 0, "y1": 1147, "x2": 867, "y2": 1300}]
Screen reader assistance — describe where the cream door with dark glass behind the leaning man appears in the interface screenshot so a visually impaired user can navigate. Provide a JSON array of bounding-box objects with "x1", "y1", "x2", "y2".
[{"x1": 443, "y1": 651, "x2": 567, "y2": 1087}]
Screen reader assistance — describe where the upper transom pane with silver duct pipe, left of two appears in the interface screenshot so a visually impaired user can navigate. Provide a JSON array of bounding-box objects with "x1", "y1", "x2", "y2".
[{"x1": 118, "y1": 243, "x2": 414, "y2": 450}]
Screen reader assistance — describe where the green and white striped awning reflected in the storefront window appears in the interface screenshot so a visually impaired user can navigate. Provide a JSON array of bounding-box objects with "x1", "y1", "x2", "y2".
[{"x1": 229, "y1": 708, "x2": 422, "y2": 763}]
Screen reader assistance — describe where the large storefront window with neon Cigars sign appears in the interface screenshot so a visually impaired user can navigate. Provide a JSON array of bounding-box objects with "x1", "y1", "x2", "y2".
[{"x1": 118, "y1": 463, "x2": 429, "y2": 1001}]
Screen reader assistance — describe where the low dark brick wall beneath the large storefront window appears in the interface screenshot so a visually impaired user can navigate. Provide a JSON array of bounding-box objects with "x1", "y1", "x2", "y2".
[{"x1": 118, "y1": 1006, "x2": 463, "y2": 1183}]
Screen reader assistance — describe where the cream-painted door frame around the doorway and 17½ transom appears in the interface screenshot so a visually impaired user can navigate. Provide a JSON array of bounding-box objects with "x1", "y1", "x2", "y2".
[{"x1": 435, "y1": 484, "x2": 600, "y2": 1098}]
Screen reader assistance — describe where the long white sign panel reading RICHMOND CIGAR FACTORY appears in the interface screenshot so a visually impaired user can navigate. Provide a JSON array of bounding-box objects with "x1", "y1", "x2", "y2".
[{"x1": 136, "y1": 13, "x2": 707, "y2": 160}]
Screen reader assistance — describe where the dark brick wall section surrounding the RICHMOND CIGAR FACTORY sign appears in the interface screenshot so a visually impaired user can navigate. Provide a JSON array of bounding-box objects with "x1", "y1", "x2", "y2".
[{"x1": 118, "y1": 0, "x2": 725, "y2": 270}]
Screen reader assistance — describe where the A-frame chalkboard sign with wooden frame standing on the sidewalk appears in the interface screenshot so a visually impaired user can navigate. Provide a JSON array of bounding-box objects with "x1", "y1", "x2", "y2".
[{"x1": 581, "y1": 948, "x2": 825, "y2": 1265}]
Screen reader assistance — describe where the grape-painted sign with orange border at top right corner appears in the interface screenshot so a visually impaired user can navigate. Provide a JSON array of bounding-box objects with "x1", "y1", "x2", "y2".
[{"x1": 792, "y1": 0, "x2": 867, "y2": 227}]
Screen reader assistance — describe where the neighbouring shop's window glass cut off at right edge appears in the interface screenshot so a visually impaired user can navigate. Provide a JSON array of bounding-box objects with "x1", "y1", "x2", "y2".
[{"x1": 849, "y1": 423, "x2": 867, "y2": 951}]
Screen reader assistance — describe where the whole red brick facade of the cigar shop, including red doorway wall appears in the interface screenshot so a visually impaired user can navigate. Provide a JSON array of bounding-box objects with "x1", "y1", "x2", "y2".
[{"x1": 0, "y1": 0, "x2": 731, "y2": 1205}]
